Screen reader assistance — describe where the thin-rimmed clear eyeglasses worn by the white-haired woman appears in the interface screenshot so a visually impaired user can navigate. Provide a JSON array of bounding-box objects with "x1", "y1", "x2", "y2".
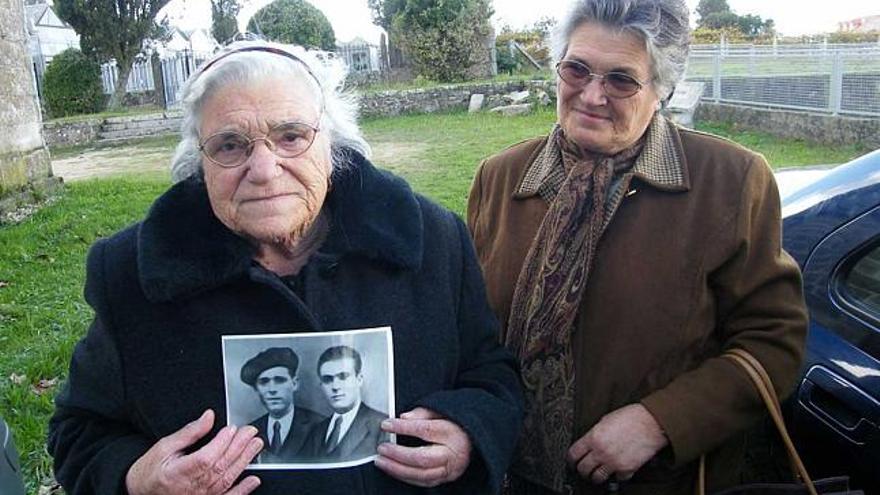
[{"x1": 199, "y1": 122, "x2": 318, "y2": 168}]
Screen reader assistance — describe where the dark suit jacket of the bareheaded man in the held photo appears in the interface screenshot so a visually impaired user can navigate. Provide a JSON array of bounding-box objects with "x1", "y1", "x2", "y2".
[{"x1": 309, "y1": 402, "x2": 389, "y2": 462}]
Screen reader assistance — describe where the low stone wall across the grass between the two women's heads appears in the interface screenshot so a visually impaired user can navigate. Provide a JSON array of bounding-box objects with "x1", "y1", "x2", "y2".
[{"x1": 360, "y1": 81, "x2": 555, "y2": 117}]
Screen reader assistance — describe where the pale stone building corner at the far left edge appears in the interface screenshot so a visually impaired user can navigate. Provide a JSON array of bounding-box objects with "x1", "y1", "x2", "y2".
[{"x1": 0, "y1": 0, "x2": 60, "y2": 218}]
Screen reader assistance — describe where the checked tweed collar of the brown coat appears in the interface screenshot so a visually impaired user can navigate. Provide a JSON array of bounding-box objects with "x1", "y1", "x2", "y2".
[{"x1": 514, "y1": 112, "x2": 690, "y2": 198}]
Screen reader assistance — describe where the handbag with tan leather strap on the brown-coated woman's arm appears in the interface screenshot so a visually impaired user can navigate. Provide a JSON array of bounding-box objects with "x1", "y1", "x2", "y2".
[{"x1": 696, "y1": 349, "x2": 864, "y2": 495}]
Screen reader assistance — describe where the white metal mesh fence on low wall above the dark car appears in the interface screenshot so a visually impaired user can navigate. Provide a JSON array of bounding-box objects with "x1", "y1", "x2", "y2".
[{"x1": 685, "y1": 44, "x2": 880, "y2": 117}]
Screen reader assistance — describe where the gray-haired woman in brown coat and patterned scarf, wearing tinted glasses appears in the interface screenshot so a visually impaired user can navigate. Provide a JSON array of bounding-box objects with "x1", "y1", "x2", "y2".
[{"x1": 468, "y1": 0, "x2": 806, "y2": 494}]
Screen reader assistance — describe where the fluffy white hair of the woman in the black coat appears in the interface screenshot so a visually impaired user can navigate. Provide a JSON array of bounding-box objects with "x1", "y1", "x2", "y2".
[{"x1": 171, "y1": 41, "x2": 370, "y2": 182}]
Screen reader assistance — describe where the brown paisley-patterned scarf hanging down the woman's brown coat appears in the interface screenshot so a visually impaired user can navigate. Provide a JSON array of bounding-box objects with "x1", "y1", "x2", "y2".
[{"x1": 505, "y1": 125, "x2": 643, "y2": 492}]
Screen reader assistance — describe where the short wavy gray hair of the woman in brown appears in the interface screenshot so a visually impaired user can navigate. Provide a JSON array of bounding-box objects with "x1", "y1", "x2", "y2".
[{"x1": 551, "y1": 0, "x2": 690, "y2": 100}]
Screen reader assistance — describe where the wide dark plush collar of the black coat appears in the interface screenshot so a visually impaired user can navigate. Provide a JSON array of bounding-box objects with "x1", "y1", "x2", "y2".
[{"x1": 137, "y1": 152, "x2": 423, "y2": 302}]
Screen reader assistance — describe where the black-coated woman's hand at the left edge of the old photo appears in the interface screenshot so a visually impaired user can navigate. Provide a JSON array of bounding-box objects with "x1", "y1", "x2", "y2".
[{"x1": 125, "y1": 409, "x2": 263, "y2": 495}]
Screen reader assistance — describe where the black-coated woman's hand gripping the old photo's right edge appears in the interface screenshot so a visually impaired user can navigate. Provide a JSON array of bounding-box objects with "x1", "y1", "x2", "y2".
[{"x1": 376, "y1": 407, "x2": 471, "y2": 487}]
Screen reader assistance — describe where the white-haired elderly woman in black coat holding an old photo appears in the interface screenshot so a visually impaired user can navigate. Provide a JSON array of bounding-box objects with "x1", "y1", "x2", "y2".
[{"x1": 49, "y1": 43, "x2": 522, "y2": 495}]
